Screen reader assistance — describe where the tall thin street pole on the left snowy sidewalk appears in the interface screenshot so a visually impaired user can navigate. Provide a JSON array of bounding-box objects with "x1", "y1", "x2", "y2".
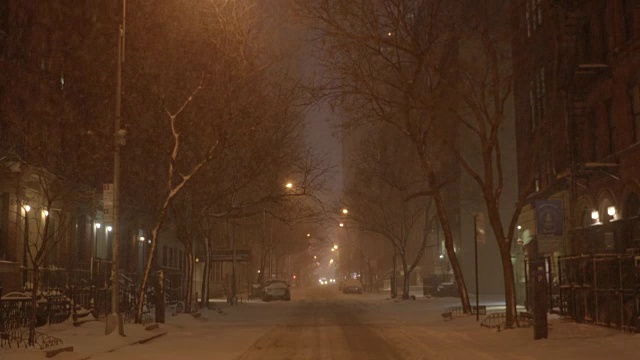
[{"x1": 105, "y1": 0, "x2": 127, "y2": 336}]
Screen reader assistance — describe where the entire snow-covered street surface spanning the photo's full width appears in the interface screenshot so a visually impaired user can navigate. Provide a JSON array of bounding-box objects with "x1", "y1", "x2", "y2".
[{"x1": 0, "y1": 286, "x2": 640, "y2": 360}]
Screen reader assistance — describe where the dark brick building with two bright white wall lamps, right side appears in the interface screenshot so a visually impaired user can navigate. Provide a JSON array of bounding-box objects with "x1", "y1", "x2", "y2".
[{"x1": 512, "y1": 0, "x2": 640, "y2": 326}]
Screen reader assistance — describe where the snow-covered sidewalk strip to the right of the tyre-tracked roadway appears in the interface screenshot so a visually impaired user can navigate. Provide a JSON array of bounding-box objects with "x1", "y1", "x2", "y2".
[{"x1": 375, "y1": 298, "x2": 640, "y2": 360}]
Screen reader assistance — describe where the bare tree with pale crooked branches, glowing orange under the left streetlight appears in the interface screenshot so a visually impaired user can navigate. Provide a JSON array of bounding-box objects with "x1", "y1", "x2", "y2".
[{"x1": 121, "y1": 0, "x2": 330, "y2": 318}]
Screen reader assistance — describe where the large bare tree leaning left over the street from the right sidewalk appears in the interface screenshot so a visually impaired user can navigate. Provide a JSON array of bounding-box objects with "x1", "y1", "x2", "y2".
[{"x1": 297, "y1": 0, "x2": 471, "y2": 313}]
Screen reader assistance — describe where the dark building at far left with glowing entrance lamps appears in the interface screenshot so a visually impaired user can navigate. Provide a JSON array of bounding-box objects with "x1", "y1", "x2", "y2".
[{"x1": 0, "y1": 0, "x2": 123, "y2": 292}]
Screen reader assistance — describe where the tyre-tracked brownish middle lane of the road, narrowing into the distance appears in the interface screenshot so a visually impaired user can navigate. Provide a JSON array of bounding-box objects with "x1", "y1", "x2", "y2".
[{"x1": 238, "y1": 288, "x2": 405, "y2": 360}]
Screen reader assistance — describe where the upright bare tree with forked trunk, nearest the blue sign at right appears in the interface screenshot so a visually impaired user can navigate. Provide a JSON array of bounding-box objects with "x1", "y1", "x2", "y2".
[{"x1": 443, "y1": 1, "x2": 544, "y2": 327}]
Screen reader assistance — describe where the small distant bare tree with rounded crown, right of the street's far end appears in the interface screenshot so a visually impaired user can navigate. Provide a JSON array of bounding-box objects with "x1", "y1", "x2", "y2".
[{"x1": 345, "y1": 128, "x2": 435, "y2": 299}]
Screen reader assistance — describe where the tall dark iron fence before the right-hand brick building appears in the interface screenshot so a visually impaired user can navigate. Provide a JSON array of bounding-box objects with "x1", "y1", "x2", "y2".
[{"x1": 558, "y1": 254, "x2": 640, "y2": 332}]
